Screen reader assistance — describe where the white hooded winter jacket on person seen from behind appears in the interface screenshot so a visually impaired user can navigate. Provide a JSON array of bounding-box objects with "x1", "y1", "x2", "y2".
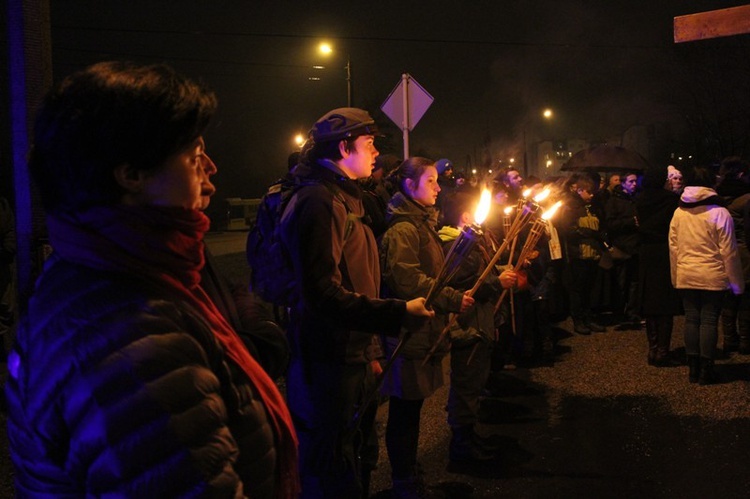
[{"x1": 669, "y1": 187, "x2": 745, "y2": 295}]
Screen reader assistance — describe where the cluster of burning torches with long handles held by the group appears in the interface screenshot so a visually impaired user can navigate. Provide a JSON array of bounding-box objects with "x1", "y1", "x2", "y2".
[{"x1": 423, "y1": 189, "x2": 562, "y2": 365}]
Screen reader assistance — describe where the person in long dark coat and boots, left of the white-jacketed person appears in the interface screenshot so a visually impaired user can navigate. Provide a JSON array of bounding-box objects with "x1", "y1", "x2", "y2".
[{"x1": 635, "y1": 167, "x2": 683, "y2": 367}]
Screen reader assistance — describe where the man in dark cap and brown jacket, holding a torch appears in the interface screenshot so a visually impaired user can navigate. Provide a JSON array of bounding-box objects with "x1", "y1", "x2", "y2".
[{"x1": 280, "y1": 107, "x2": 434, "y2": 498}]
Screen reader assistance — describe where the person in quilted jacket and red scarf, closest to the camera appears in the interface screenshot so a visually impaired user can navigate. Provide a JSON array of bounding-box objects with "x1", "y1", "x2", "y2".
[{"x1": 6, "y1": 62, "x2": 299, "y2": 499}]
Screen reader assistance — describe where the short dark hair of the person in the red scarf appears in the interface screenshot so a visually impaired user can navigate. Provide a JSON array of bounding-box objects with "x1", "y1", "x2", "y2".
[{"x1": 29, "y1": 62, "x2": 216, "y2": 212}]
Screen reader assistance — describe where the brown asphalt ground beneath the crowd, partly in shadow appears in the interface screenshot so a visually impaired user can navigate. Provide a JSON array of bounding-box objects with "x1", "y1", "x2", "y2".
[{"x1": 0, "y1": 234, "x2": 750, "y2": 499}]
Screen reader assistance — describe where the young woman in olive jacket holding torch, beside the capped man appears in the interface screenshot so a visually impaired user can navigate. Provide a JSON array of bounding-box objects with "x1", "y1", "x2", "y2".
[{"x1": 380, "y1": 157, "x2": 474, "y2": 497}]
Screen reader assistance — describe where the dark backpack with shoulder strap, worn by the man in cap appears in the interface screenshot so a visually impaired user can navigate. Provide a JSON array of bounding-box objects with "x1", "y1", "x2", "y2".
[{"x1": 245, "y1": 177, "x2": 357, "y2": 307}]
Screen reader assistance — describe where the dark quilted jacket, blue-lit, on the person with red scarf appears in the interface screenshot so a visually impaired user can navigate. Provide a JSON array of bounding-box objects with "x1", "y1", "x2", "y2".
[{"x1": 6, "y1": 265, "x2": 251, "y2": 497}]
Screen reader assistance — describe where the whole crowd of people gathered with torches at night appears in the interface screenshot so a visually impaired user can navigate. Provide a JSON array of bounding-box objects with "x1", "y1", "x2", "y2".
[{"x1": 6, "y1": 59, "x2": 750, "y2": 499}]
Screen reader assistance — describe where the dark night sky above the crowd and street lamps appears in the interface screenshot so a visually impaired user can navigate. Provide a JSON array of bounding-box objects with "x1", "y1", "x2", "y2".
[{"x1": 50, "y1": 0, "x2": 747, "y2": 218}]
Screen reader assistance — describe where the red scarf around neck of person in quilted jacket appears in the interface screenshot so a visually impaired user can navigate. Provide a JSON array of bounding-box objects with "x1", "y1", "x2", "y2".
[{"x1": 47, "y1": 205, "x2": 299, "y2": 499}]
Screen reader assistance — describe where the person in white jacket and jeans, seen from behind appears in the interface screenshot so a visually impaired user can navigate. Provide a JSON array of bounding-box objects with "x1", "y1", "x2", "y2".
[{"x1": 669, "y1": 168, "x2": 745, "y2": 385}]
